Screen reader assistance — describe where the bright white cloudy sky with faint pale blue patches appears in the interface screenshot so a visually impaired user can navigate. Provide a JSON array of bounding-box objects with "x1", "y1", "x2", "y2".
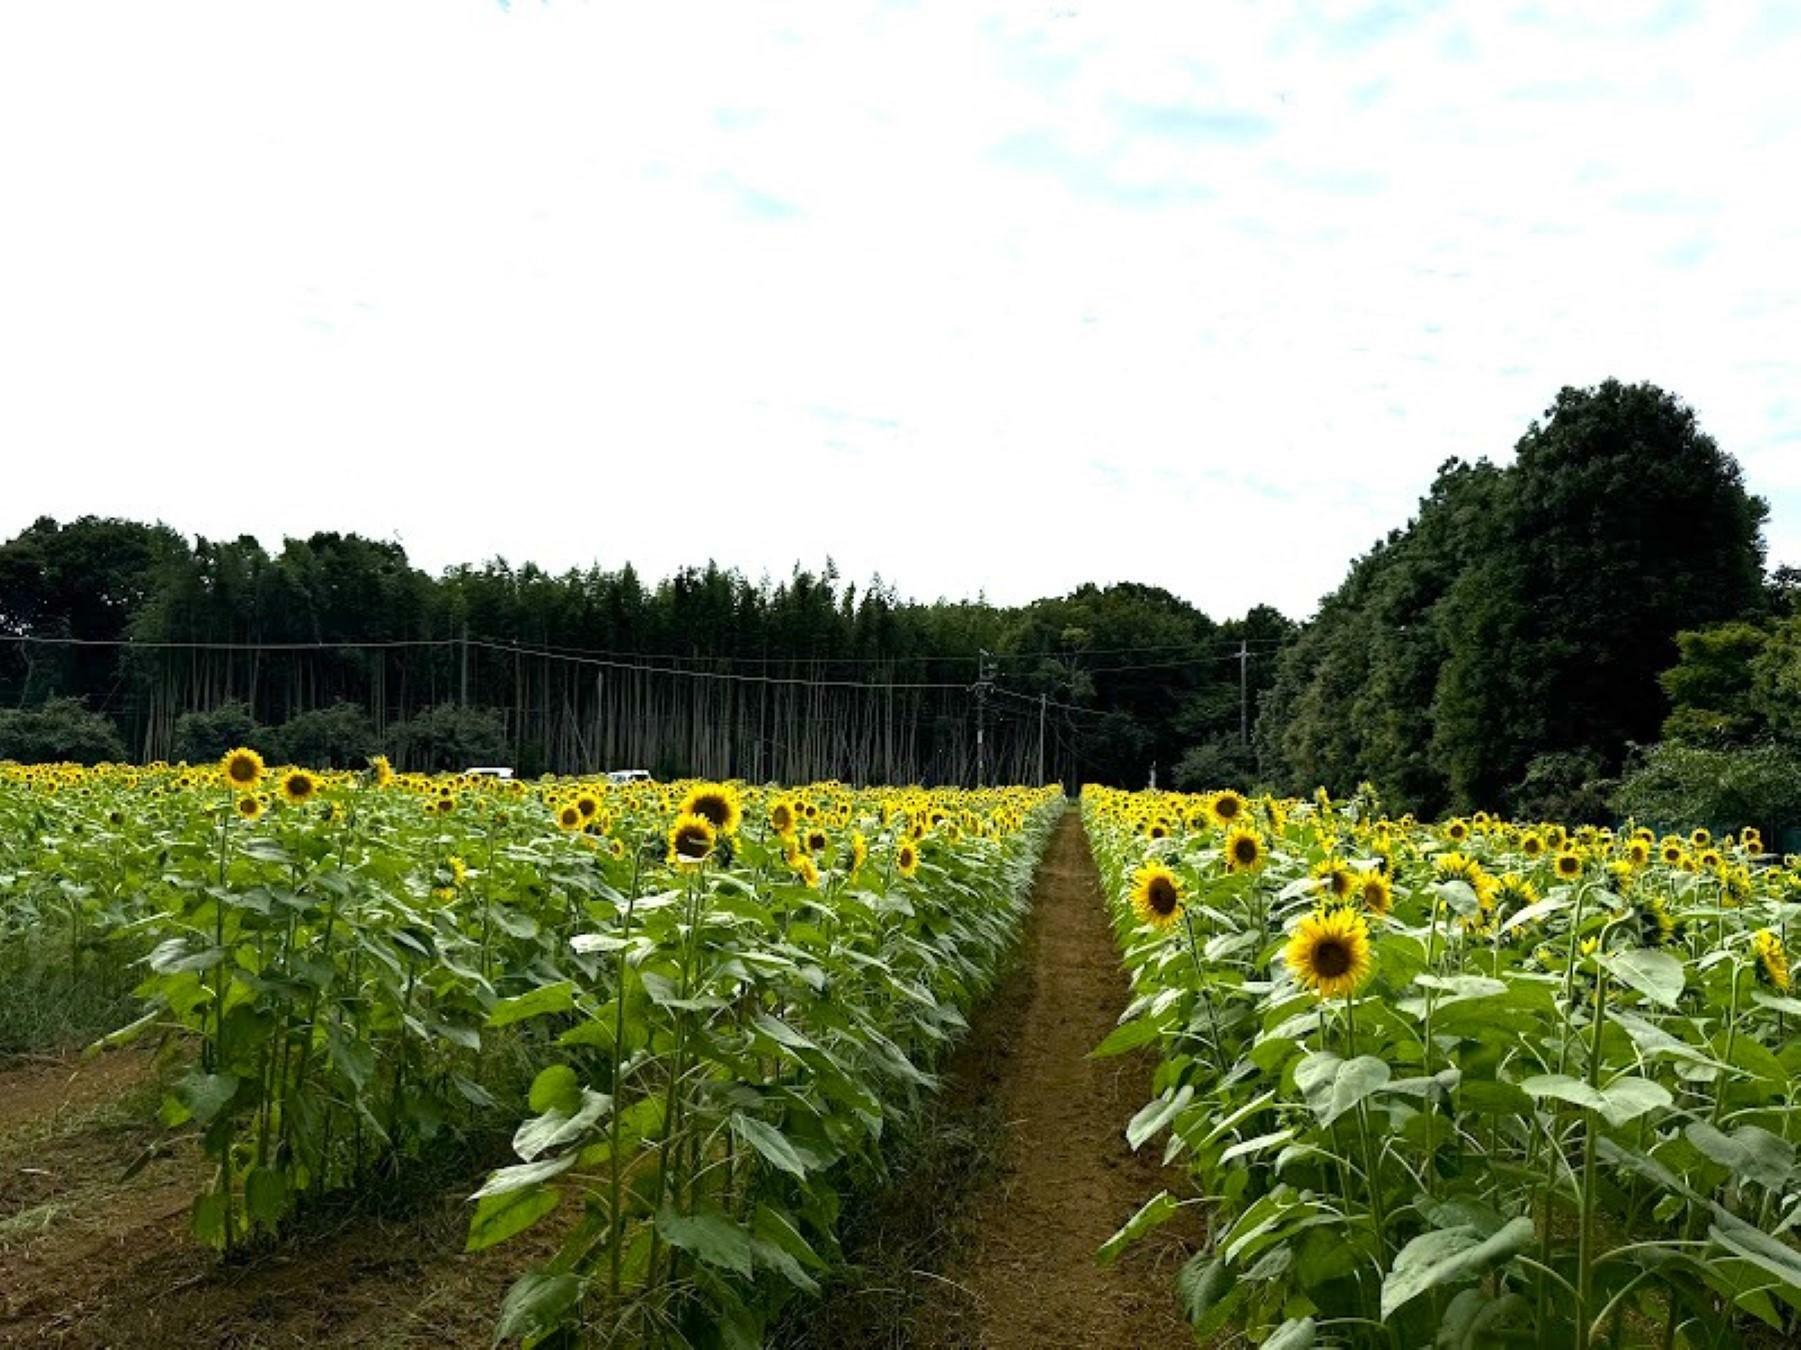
[{"x1": 0, "y1": 0, "x2": 1801, "y2": 617}]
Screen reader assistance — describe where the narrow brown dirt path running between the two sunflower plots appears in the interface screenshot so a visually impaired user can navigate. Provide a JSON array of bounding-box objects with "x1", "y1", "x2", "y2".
[{"x1": 949, "y1": 810, "x2": 1192, "y2": 1350}]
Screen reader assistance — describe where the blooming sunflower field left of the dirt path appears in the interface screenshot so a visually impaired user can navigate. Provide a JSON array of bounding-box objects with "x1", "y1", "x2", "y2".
[{"x1": 0, "y1": 763, "x2": 1063, "y2": 1345}]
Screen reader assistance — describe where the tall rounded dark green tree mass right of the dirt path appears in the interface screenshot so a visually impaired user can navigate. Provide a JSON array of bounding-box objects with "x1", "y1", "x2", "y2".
[{"x1": 1257, "y1": 382, "x2": 1772, "y2": 824}]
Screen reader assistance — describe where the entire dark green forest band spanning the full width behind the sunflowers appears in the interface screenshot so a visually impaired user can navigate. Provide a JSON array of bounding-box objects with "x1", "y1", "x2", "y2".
[{"x1": 0, "y1": 382, "x2": 1801, "y2": 823}]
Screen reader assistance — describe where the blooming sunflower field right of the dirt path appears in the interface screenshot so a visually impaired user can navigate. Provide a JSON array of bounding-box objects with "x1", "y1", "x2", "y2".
[{"x1": 1082, "y1": 788, "x2": 1801, "y2": 1350}]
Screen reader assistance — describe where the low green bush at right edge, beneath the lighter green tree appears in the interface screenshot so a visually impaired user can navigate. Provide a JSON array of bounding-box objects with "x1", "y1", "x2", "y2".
[{"x1": 1614, "y1": 742, "x2": 1801, "y2": 841}]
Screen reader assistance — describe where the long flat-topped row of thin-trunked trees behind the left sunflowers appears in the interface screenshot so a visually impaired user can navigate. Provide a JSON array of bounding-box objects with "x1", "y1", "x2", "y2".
[{"x1": 0, "y1": 518, "x2": 1293, "y2": 785}]
